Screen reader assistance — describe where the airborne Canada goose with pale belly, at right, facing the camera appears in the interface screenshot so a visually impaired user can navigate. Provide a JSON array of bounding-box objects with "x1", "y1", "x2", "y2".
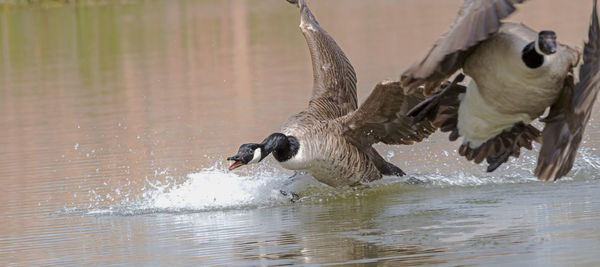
[{"x1": 401, "y1": 0, "x2": 600, "y2": 181}]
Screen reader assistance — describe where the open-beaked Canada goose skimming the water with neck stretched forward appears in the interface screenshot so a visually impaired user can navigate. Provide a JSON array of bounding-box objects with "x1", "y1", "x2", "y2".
[{"x1": 227, "y1": 0, "x2": 435, "y2": 187}]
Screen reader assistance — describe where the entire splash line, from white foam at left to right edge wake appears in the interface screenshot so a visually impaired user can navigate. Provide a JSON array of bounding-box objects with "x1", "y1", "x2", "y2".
[{"x1": 74, "y1": 148, "x2": 600, "y2": 215}]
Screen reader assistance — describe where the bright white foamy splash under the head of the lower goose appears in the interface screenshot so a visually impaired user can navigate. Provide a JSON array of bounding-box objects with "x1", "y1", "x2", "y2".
[{"x1": 80, "y1": 162, "x2": 321, "y2": 216}]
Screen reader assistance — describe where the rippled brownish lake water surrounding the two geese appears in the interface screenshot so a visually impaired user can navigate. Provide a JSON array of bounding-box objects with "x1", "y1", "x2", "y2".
[{"x1": 0, "y1": 0, "x2": 600, "y2": 266}]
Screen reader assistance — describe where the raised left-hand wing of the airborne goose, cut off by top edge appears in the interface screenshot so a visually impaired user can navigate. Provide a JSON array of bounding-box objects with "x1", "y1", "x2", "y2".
[{"x1": 401, "y1": 0, "x2": 525, "y2": 95}]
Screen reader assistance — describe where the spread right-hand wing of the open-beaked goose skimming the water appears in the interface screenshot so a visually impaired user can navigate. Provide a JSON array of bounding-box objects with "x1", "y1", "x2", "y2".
[{"x1": 343, "y1": 82, "x2": 436, "y2": 150}]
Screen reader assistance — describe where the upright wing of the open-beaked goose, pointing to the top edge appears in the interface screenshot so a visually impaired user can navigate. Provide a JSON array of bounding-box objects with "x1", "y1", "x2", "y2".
[{"x1": 292, "y1": 0, "x2": 358, "y2": 120}]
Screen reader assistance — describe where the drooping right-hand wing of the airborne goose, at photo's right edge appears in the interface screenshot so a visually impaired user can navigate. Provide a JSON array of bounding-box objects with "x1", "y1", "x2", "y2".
[{"x1": 535, "y1": 0, "x2": 600, "y2": 181}]
